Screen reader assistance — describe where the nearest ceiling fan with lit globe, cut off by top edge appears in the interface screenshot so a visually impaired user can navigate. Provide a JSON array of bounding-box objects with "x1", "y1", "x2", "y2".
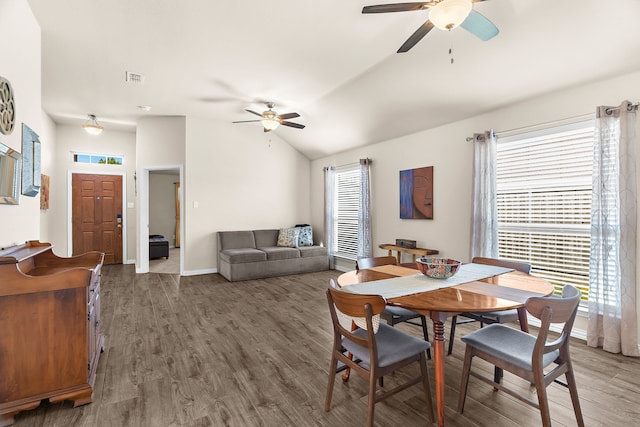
[{"x1": 362, "y1": 0, "x2": 500, "y2": 53}]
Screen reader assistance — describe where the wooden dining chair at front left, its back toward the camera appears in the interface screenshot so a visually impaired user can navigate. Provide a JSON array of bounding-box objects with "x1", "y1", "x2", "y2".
[{"x1": 324, "y1": 287, "x2": 434, "y2": 426}]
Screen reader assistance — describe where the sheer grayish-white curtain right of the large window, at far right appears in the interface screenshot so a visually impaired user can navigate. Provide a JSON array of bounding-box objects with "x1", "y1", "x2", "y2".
[{"x1": 587, "y1": 101, "x2": 640, "y2": 356}]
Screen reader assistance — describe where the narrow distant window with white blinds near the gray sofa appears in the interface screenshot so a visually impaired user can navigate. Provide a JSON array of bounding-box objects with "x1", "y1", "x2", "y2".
[{"x1": 333, "y1": 165, "x2": 360, "y2": 261}]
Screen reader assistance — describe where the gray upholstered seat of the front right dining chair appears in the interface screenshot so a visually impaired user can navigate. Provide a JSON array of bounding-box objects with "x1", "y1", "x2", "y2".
[{"x1": 461, "y1": 323, "x2": 560, "y2": 371}]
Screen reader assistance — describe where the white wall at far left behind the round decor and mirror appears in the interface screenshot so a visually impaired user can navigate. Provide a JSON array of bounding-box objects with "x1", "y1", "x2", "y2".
[{"x1": 0, "y1": 0, "x2": 41, "y2": 247}]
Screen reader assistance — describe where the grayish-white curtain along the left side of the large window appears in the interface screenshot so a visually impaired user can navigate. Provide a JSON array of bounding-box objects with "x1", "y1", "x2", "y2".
[{"x1": 471, "y1": 131, "x2": 498, "y2": 259}]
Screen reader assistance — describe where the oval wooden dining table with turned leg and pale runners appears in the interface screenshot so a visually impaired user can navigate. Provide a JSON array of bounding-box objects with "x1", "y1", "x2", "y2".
[{"x1": 338, "y1": 263, "x2": 554, "y2": 426}]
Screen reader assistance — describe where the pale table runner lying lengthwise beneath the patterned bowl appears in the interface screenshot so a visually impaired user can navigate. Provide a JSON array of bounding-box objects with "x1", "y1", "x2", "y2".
[{"x1": 345, "y1": 263, "x2": 513, "y2": 299}]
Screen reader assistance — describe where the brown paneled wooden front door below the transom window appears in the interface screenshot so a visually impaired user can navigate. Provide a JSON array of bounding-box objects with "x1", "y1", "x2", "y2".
[{"x1": 71, "y1": 174, "x2": 123, "y2": 264}]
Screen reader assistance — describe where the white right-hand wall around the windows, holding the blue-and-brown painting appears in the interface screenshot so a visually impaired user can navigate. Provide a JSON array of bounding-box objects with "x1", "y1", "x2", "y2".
[{"x1": 310, "y1": 73, "x2": 640, "y2": 270}]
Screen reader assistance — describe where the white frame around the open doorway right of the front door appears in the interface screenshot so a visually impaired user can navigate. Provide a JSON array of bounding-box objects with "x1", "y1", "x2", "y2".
[{"x1": 136, "y1": 165, "x2": 187, "y2": 276}]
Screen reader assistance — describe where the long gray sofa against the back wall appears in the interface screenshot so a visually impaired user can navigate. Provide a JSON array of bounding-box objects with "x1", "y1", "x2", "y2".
[{"x1": 217, "y1": 229, "x2": 329, "y2": 282}]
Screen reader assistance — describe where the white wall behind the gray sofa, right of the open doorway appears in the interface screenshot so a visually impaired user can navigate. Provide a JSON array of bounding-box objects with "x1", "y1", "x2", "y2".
[{"x1": 184, "y1": 117, "x2": 310, "y2": 272}]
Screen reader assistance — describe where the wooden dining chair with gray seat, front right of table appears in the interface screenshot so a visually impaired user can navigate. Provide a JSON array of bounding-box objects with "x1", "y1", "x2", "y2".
[{"x1": 458, "y1": 285, "x2": 584, "y2": 427}]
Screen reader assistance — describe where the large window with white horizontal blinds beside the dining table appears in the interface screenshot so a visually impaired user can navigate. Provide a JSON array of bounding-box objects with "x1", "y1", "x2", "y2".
[{"x1": 496, "y1": 121, "x2": 594, "y2": 301}]
